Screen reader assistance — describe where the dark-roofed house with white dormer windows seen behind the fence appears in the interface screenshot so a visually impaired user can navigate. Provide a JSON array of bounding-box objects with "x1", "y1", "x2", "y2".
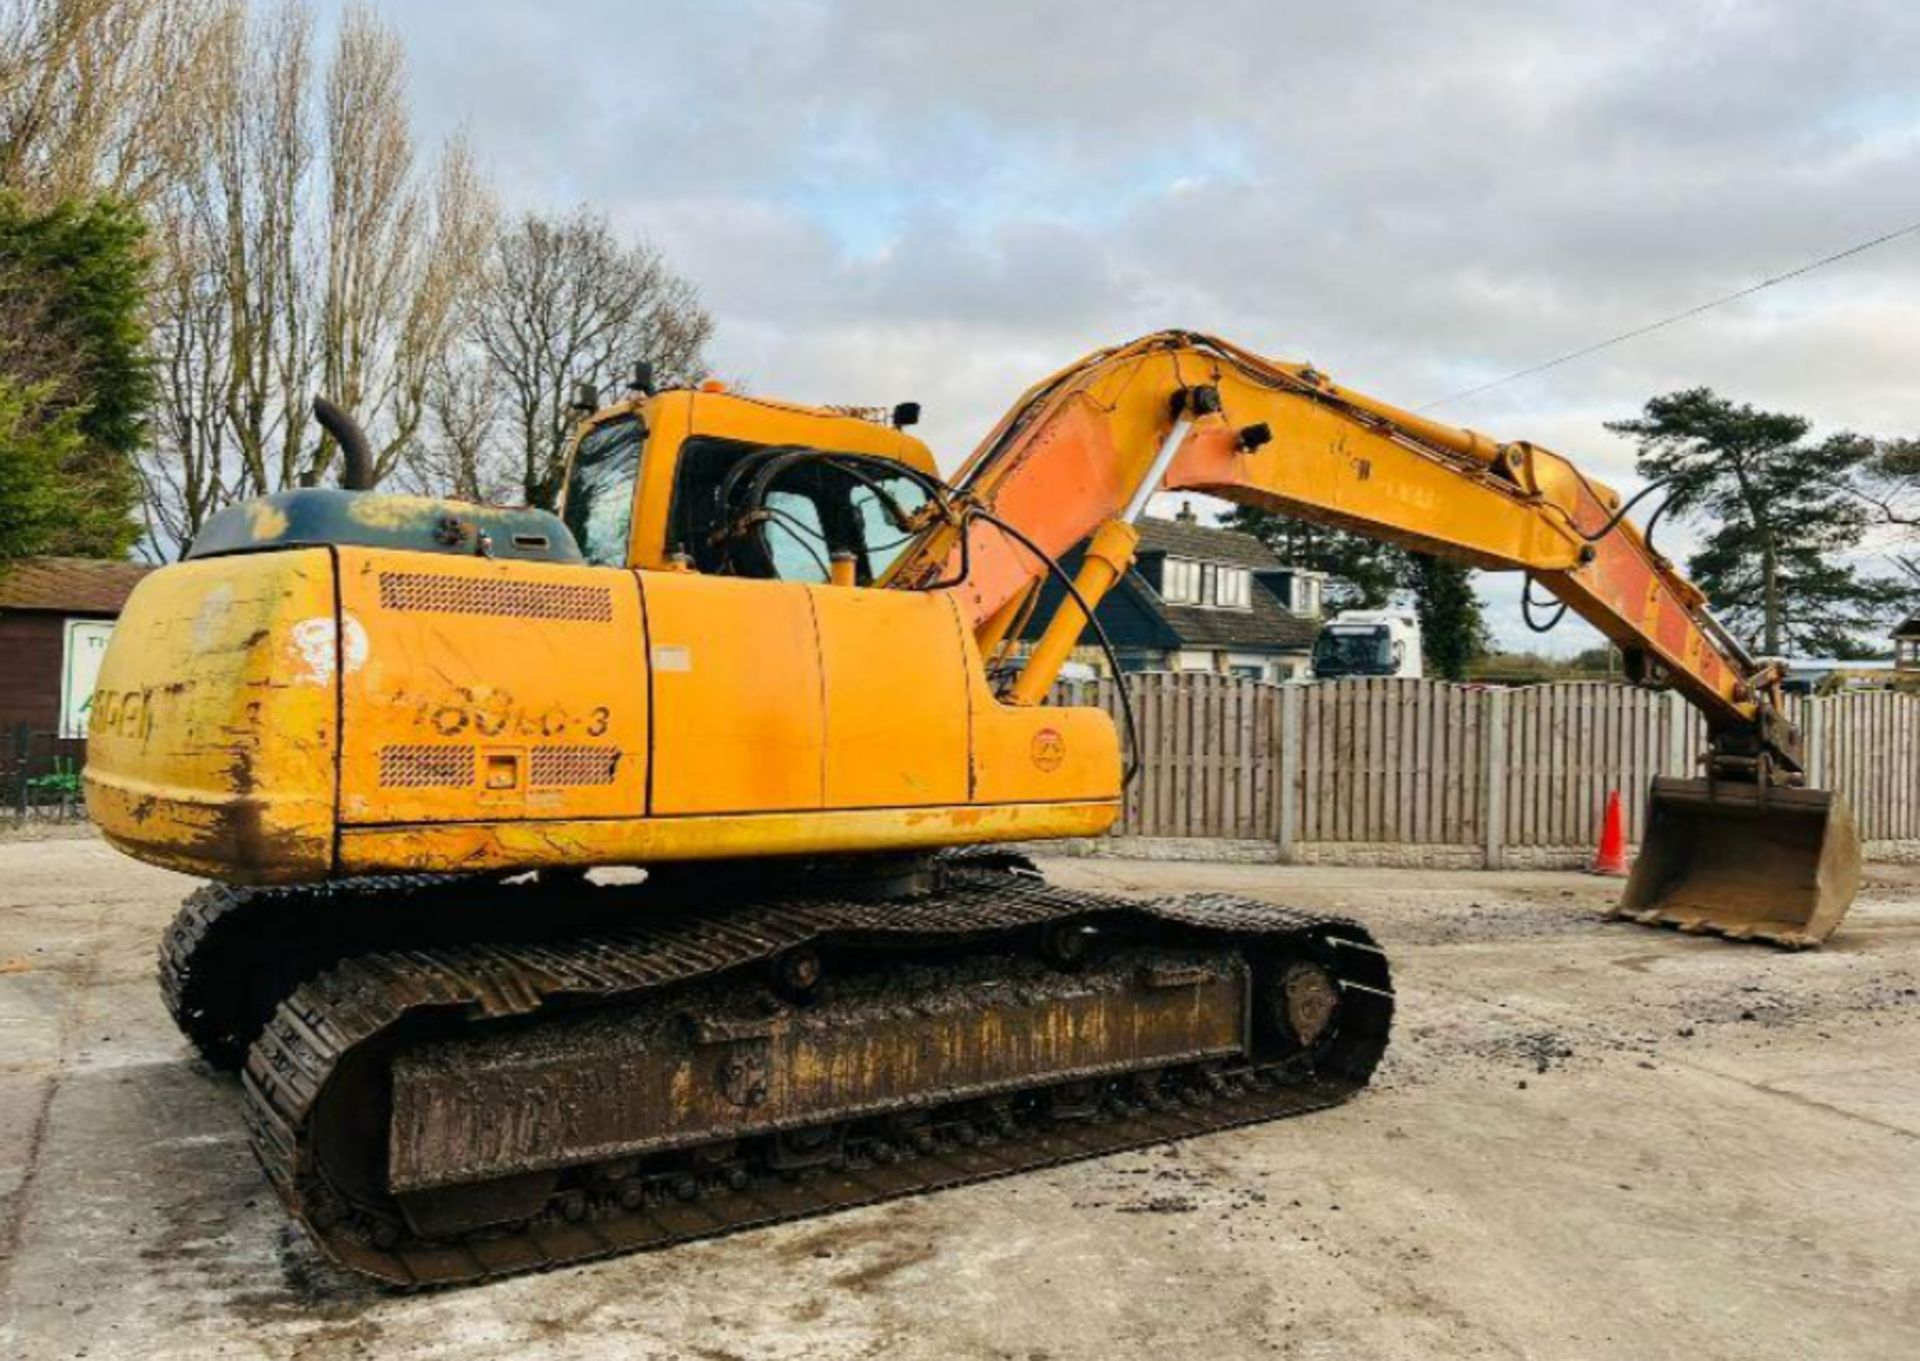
[{"x1": 1025, "y1": 507, "x2": 1327, "y2": 681}]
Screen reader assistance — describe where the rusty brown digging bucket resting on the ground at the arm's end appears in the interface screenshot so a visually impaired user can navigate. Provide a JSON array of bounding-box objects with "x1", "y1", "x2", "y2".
[{"x1": 1609, "y1": 777, "x2": 1860, "y2": 950}]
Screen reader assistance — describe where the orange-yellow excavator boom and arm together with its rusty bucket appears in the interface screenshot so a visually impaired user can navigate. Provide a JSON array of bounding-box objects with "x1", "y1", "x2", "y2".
[{"x1": 891, "y1": 332, "x2": 1859, "y2": 946}]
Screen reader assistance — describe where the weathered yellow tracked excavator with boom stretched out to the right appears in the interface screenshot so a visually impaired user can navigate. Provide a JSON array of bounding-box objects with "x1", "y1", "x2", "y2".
[{"x1": 86, "y1": 332, "x2": 1859, "y2": 1286}]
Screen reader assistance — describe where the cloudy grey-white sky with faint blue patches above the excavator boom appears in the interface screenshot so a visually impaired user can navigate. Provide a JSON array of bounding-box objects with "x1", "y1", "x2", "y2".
[{"x1": 323, "y1": 0, "x2": 1920, "y2": 651}]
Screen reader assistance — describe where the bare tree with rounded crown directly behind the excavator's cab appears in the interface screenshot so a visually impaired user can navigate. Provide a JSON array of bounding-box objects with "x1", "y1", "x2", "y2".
[{"x1": 472, "y1": 209, "x2": 712, "y2": 507}]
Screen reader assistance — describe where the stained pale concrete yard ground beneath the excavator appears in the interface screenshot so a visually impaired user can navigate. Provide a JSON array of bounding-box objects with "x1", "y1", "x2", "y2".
[{"x1": 0, "y1": 839, "x2": 1920, "y2": 1361}]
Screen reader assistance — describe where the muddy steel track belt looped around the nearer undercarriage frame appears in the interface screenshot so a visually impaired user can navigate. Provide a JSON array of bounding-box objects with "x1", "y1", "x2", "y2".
[{"x1": 244, "y1": 872, "x2": 1392, "y2": 1286}]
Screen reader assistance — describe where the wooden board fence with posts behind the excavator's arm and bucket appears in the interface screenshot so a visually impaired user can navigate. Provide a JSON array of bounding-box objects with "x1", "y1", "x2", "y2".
[{"x1": 1062, "y1": 672, "x2": 1920, "y2": 866}]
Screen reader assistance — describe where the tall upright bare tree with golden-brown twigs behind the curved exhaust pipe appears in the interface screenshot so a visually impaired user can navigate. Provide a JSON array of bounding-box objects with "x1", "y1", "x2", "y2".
[{"x1": 142, "y1": 0, "x2": 495, "y2": 543}]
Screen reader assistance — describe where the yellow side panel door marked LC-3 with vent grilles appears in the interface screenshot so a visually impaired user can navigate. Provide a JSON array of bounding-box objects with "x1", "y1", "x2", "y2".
[{"x1": 337, "y1": 547, "x2": 647, "y2": 824}]
